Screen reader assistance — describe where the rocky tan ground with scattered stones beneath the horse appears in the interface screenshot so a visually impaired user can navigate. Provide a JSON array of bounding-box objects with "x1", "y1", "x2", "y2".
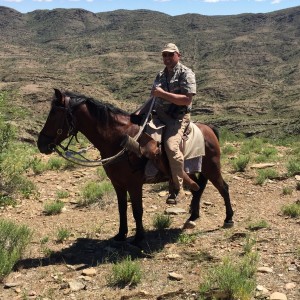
[{"x1": 0, "y1": 152, "x2": 300, "y2": 300}]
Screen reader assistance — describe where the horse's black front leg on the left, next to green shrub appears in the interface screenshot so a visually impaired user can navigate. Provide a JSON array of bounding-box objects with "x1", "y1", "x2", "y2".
[{"x1": 114, "y1": 187, "x2": 128, "y2": 241}]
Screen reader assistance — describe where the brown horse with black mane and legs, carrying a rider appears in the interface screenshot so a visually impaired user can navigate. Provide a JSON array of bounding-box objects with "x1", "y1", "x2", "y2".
[{"x1": 37, "y1": 90, "x2": 233, "y2": 243}]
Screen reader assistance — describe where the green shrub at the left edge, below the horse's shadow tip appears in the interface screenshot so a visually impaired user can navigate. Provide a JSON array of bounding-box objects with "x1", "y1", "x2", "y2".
[{"x1": 0, "y1": 220, "x2": 32, "y2": 281}]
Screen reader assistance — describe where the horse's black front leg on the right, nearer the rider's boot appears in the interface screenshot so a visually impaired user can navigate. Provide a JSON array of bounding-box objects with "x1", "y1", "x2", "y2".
[{"x1": 128, "y1": 184, "x2": 145, "y2": 244}]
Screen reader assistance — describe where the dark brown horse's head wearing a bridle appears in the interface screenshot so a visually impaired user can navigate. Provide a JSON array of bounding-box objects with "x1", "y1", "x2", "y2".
[{"x1": 37, "y1": 89, "x2": 74, "y2": 154}]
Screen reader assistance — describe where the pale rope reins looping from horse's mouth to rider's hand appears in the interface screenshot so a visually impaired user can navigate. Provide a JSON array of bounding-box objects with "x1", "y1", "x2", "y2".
[{"x1": 54, "y1": 97, "x2": 155, "y2": 167}]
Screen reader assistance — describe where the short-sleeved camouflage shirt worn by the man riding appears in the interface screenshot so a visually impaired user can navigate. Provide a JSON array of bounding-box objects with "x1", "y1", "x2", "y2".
[{"x1": 153, "y1": 62, "x2": 196, "y2": 112}]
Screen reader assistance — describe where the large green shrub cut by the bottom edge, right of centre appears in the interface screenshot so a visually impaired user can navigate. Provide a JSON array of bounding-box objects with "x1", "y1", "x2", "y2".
[{"x1": 199, "y1": 253, "x2": 258, "y2": 300}]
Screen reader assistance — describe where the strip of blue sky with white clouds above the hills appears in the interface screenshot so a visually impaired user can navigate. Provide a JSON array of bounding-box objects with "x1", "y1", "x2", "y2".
[{"x1": 0, "y1": 0, "x2": 300, "y2": 16}]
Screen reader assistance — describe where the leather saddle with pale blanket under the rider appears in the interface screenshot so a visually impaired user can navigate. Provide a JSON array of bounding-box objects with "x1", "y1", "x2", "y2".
[{"x1": 122, "y1": 115, "x2": 205, "y2": 191}]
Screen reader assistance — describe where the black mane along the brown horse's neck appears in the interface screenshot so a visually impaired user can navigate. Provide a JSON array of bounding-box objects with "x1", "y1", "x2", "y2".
[{"x1": 65, "y1": 91, "x2": 129, "y2": 124}]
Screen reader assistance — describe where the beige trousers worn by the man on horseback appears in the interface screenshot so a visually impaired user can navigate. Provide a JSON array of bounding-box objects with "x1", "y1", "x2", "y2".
[{"x1": 157, "y1": 112, "x2": 190, "y2": 190}]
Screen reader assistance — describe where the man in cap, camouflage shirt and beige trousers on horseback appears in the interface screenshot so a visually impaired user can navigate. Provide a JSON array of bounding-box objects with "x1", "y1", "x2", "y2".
[{"x1": 151, "y1": 43, "x2": 196, "y2": 204}]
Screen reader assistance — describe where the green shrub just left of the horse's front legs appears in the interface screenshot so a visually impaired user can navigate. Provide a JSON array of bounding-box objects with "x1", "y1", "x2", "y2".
[{"x1": 78, "y1": 181, "x2": 114, "y2": 206}]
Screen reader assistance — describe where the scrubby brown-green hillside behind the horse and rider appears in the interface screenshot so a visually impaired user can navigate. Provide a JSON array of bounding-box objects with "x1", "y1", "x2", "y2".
[{"x1": 0, "y1": 6, "x2": 300, "y2": 136}]
